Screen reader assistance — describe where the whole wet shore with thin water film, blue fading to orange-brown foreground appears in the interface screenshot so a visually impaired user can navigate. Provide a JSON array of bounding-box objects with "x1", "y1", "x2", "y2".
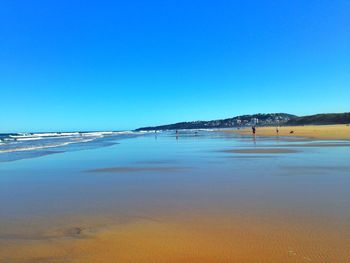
[{"x1": 0, "y1": 131, "x2": 350, "y2": 262}]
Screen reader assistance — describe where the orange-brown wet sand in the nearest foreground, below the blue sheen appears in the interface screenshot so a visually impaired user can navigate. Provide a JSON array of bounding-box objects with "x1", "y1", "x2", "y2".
[{"x1": 0, "y1": 217, "x2": 350, "y2": 263}]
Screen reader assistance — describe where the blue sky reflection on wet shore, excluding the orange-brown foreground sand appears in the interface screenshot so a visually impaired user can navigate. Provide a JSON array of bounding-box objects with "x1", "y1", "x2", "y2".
[{"x1": 0, "y1": 131, "x2": 350, "y2": 262}]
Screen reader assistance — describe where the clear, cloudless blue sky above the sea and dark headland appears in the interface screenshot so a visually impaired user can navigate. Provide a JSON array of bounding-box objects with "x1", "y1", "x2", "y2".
[{"x1": 0, "y1": 0, "x2": 350, "y2": 132}]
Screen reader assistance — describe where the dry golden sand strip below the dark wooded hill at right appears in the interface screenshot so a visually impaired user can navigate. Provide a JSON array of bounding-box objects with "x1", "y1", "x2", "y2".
[{"x1": 224, "y1": 124, "x2": 350, "y2": 140}]
